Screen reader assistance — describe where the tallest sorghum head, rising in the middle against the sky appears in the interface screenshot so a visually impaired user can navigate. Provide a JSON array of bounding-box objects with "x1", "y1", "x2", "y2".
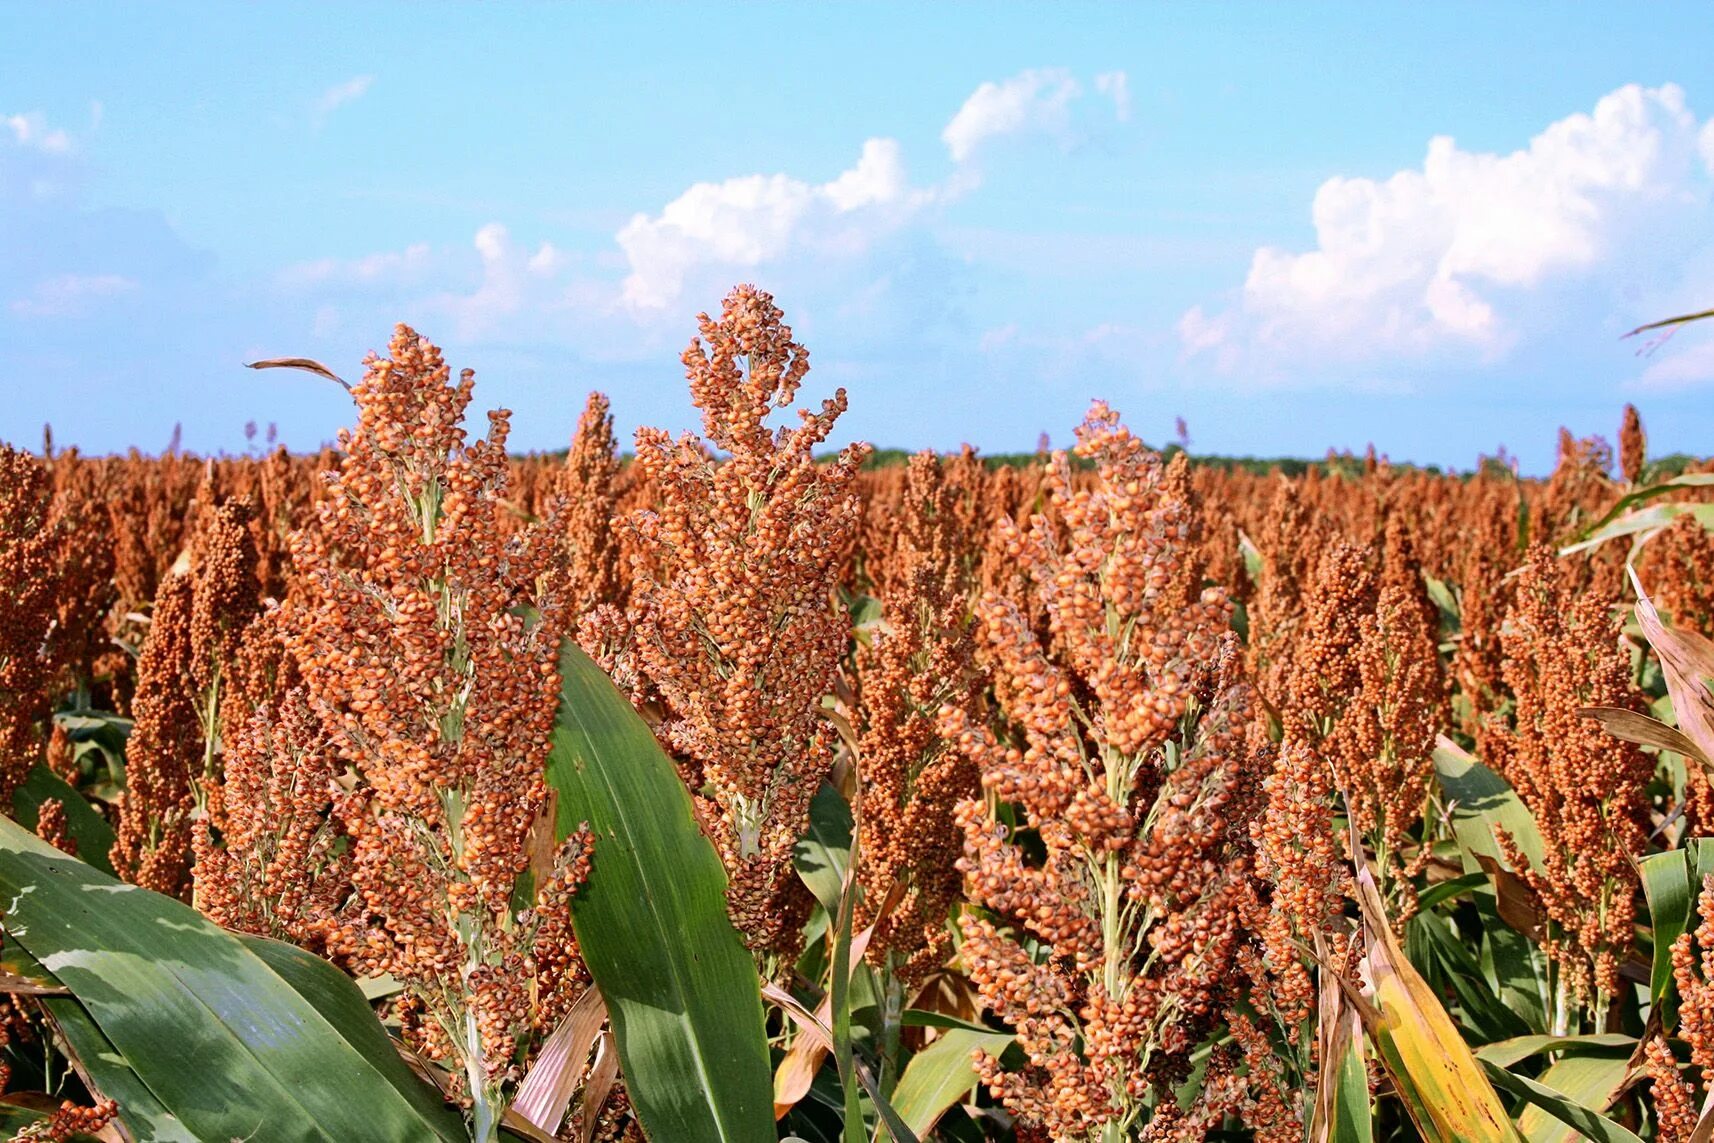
[{"x1": 627, "y1": 286, "x2": 867, "y2": 956}]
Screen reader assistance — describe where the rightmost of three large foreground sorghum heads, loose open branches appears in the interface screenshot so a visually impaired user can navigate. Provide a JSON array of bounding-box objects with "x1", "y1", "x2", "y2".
[{"x1": 943, "y1": 403, "x2": 1282, "y2": 1141}]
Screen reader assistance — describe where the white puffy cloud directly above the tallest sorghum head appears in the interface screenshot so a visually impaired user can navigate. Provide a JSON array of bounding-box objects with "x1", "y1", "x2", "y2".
[{"x1": 617, "y1": 139, "x2": 938, "y2": 310}]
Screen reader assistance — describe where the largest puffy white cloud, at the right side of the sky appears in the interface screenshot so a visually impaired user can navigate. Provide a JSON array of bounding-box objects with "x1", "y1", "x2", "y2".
[{"x1": 1179, "y1": 84, "x2": 1711, "y2": 380}]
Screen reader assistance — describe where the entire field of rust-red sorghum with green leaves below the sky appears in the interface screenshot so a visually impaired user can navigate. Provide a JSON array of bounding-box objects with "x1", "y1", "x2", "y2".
[{"x1": 10, "y1": 286, "x2": 1714, "y2": 1143}]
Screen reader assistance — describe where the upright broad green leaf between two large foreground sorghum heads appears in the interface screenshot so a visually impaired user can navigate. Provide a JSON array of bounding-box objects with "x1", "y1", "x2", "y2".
[{"x1": 547, "y1": 639, "x2": 776, "y2": 1143}]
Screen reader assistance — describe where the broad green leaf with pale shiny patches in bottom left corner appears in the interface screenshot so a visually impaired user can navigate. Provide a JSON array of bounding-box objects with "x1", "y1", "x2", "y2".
[{"x1": 0, "y1": 819, "x2": 464, "y2": 1143}]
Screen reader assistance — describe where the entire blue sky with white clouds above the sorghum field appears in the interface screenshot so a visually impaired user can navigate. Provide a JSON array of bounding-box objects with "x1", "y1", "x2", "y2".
[{"x1": 0, "y1": 3, "x2": 1714, "y2": 470}]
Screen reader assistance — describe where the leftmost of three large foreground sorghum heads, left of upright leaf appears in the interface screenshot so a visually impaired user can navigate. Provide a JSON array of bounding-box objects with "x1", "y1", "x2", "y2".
[{"x1": 277, "y1": 326, "x2": 588, "y2": 1140}]
